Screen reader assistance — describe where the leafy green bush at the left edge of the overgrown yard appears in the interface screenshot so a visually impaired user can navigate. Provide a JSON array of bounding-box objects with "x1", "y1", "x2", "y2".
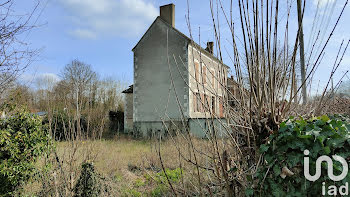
[{"x1": 0, "y1": 106, "x2": 52, "y2": 196}]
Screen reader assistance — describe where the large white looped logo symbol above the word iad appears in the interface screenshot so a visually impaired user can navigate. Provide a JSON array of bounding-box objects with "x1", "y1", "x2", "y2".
[{"x1": 304, "y1": 150, "x2": 349, "y2": 181}]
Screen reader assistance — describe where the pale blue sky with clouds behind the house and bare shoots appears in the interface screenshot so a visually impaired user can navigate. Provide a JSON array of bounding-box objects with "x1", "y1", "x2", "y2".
[{"x1": 14, "y1": 0, "x2": 350, "y2": 93}]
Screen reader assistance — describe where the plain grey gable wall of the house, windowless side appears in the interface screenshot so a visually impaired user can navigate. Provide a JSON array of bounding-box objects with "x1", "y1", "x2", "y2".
[{"x1": 134, "y1": 19, "x2": 188, "y2": 126}]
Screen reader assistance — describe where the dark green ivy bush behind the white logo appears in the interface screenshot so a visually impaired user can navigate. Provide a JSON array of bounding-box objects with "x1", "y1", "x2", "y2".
[{"x1": 252, "y1": 115, "x2": 350, "y2": 196}]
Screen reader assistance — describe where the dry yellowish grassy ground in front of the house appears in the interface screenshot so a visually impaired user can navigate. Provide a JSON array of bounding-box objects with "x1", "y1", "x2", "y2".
[{"x1": 23, "y1": 138, "x2": 190, "y2": 196}]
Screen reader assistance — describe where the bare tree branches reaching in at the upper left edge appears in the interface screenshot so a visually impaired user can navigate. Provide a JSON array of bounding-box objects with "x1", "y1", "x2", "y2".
[{"x1": 0, "y1": 0, "x2": 39, "y2": 93}]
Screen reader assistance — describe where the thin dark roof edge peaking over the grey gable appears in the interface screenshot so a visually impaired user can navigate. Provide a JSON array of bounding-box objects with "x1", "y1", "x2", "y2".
[{"x1": 132, "y1": 16, "x2": 230, "y2": 68}]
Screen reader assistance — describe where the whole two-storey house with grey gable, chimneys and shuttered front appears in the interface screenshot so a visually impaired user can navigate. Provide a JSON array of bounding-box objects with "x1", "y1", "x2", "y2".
[{"x1": 123, "y1": 4, "x2": 229, "y2": 137}]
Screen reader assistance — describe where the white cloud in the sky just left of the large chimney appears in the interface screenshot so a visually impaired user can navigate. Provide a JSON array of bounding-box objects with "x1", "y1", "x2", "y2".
[{"x1": 59, "y1": 0, "x2": 158, "y2": 39}]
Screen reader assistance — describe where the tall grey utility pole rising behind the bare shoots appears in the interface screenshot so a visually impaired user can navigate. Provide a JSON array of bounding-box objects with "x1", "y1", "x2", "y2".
[{"x1": 297, "y1": 0, "x2": 307, "y2": 104}]
